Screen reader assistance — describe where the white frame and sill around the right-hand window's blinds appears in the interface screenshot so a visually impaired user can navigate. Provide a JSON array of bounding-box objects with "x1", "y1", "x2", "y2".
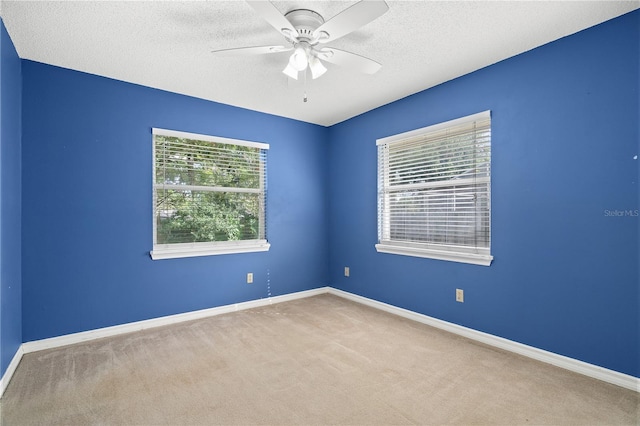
[{"x1": 375, "y1": 111, "x2": 493, "y2": 266}]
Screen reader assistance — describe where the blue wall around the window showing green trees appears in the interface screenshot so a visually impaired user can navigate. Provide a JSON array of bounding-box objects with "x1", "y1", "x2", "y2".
[{"x1": 22, "y1": 61, "x2": 328, "y2": 341}]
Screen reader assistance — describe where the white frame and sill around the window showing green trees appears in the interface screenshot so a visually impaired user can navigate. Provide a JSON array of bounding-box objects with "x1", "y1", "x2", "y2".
[{"x1": 149, "y1": 127, "x2": 271, "y2": 260}]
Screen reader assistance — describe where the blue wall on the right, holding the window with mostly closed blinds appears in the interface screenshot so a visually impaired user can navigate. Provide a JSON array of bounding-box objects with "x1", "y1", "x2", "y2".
[{"x1": 329, "y1": 12, "x2": 640, "y2": 376}]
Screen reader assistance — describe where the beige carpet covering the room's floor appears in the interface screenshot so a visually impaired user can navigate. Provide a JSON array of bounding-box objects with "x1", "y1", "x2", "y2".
[{"x1": 0, "y1": 295, "x2": 640, "y2": 426}]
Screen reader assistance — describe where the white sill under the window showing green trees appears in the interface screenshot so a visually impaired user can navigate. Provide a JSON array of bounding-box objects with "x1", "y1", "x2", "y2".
[{"x1": 149, "y1": 240, "x2": 271, "y2": 260}]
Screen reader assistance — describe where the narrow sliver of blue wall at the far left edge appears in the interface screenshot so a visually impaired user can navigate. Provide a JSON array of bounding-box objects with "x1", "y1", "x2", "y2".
[{"x1": 0, "y1": 20, "x2": 22, "y2": 377}]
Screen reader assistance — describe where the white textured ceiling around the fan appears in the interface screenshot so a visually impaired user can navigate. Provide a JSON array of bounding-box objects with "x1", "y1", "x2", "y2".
[{"x1": 0, "y1": 0, "x2": 640, "y2": 126}]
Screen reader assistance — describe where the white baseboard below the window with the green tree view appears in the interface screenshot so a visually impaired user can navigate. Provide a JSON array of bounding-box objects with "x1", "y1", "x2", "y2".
[{"x1": 22, "y1": 287, "x2": 328, "y2": 353}]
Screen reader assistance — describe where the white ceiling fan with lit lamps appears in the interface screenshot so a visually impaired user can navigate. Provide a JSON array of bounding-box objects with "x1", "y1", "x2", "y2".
[{"x1": 212, "y1": 0, "x2": 389, "y2": 80}]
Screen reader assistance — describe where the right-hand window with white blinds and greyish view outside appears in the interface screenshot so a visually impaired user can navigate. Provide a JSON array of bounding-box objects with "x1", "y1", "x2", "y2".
[{"x1": 376, "y1": 111, "x2": 493, "y2": 266}]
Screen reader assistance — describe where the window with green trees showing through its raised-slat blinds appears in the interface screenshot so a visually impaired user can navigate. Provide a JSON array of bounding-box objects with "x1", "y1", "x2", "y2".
[{"x1": 151, "y1": 129, "x2": 269, "y2": 259}]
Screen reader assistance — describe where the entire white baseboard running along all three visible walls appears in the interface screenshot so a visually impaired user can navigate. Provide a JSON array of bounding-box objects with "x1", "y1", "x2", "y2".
[{"x1": 0, "y1": 287, "x2": 640, "y2": 398}]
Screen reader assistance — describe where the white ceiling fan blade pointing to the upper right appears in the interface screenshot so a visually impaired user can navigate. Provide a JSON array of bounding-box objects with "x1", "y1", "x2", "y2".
[{"x1": 312, "y1": 0, "x2": 389, "y2": 43}]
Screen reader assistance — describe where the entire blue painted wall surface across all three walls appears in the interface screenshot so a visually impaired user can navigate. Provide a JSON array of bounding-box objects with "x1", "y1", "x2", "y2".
[{"x1": 6, "y1": 8, "x2": 640, "y2": 376}]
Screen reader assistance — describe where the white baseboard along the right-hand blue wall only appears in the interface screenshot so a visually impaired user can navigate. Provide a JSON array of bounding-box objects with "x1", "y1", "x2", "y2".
[{"x1": 328, "y1": 287, "x2": 640, "y2": 392}]
